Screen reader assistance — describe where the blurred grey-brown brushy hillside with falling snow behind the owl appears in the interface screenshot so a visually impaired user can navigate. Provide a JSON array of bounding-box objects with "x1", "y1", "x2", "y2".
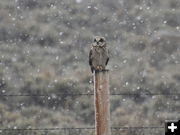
[{"x1": 0, "y1": 0, "x2": 180, "y2": 135}]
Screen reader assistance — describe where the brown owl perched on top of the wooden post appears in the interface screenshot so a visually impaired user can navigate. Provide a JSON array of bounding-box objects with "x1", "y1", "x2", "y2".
[{"x1": 89, "y1": 36, "x2": 109, "y2": 73}]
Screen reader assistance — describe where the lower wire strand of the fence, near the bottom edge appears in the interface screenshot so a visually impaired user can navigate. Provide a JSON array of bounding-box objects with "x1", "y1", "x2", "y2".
[{"x1": 0, "y1": 126, "x2": 164, "y2": 131}]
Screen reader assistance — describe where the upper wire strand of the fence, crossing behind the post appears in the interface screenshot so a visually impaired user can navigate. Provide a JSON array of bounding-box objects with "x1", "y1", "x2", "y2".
[{"x1": 0, "y1": 92, "x2": 180, "y2": 97}]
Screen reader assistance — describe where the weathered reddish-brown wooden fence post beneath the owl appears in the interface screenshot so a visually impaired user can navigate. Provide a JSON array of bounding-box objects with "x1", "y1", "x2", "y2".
[{"x1": 94, "y1": 70, "x2": 111, "y2": 135}]
